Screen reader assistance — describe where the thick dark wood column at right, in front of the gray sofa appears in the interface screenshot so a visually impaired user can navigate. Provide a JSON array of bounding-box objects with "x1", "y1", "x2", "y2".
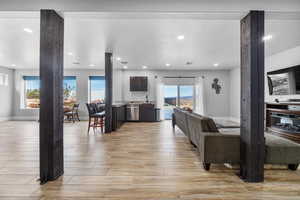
[{"x1": 240, "y1": 11, "x2": 265, "y2": 182}]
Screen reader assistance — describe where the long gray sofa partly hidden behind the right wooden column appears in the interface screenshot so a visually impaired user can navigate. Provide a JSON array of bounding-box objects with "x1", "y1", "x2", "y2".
[{"x1": 173, "y1": 108, "x2": 300, "y2": 170}]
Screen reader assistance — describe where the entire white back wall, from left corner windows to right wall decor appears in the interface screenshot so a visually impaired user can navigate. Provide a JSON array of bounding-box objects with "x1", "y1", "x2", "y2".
[{"x1": 13, "y1": 67, "x2": 230, "y2": 120}]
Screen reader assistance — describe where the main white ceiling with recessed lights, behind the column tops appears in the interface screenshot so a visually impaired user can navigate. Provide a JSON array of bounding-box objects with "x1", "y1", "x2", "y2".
[{"x1": 0, "y1": 12, "x2": 300, "y2": 70}]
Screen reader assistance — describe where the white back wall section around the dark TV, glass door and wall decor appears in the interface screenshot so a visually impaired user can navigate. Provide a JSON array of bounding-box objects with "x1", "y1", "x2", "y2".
[{"x1": 123, "y1": 70, "x2": 230, "y2": 117}]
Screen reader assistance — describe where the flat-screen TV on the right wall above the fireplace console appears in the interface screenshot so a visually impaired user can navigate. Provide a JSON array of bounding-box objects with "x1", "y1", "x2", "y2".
[{"x1": 267, "y1": 65, "x2": 300, "y2": 95}]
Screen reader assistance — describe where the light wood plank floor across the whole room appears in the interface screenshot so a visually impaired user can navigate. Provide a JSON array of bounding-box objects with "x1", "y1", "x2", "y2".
[{"x1": 0, "y1": 121, "x2": 300, "y2": 200}]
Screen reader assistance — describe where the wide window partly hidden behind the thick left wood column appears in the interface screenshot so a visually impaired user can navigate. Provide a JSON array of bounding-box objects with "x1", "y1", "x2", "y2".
[{"x1": 23, "y1": 76, "x2": 76, "y2": 109}]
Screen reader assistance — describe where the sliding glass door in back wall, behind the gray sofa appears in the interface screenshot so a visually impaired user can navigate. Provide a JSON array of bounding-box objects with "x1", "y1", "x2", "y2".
[{"x1": 164, "y1": 85, "x2": 194, "y2": 119}]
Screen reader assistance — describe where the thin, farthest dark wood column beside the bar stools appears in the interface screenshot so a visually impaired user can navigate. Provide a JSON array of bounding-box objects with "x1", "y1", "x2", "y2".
[{"x1": 105, "y1": 53, "x2": 113, "y2": 133}]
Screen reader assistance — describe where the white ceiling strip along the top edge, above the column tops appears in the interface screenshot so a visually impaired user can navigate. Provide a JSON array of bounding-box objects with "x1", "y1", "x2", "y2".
[{"x1": 0, "y1": 0, "x2": 300, "y2": 12}]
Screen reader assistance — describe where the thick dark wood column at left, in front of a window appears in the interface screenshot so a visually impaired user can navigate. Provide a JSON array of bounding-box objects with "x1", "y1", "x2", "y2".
[{"x1": 40, "y1": 10, "x2": 64, "y2": 184}]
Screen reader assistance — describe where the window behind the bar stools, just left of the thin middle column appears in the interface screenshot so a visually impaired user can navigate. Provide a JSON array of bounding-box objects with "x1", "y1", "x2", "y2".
[{"x1": 89, "y1": 76, "x2": 105, "y2": 103}]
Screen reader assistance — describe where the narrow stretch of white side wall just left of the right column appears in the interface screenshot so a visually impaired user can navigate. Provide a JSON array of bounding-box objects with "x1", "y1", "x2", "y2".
[{"x1": 229, "y1": 68, "x2": 241, "y2": 122}]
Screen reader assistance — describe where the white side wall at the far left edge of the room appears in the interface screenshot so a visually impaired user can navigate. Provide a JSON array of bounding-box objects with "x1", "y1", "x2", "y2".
[{"x1": 0, "y1": 67, "x2": 14, "y2": 121}]
